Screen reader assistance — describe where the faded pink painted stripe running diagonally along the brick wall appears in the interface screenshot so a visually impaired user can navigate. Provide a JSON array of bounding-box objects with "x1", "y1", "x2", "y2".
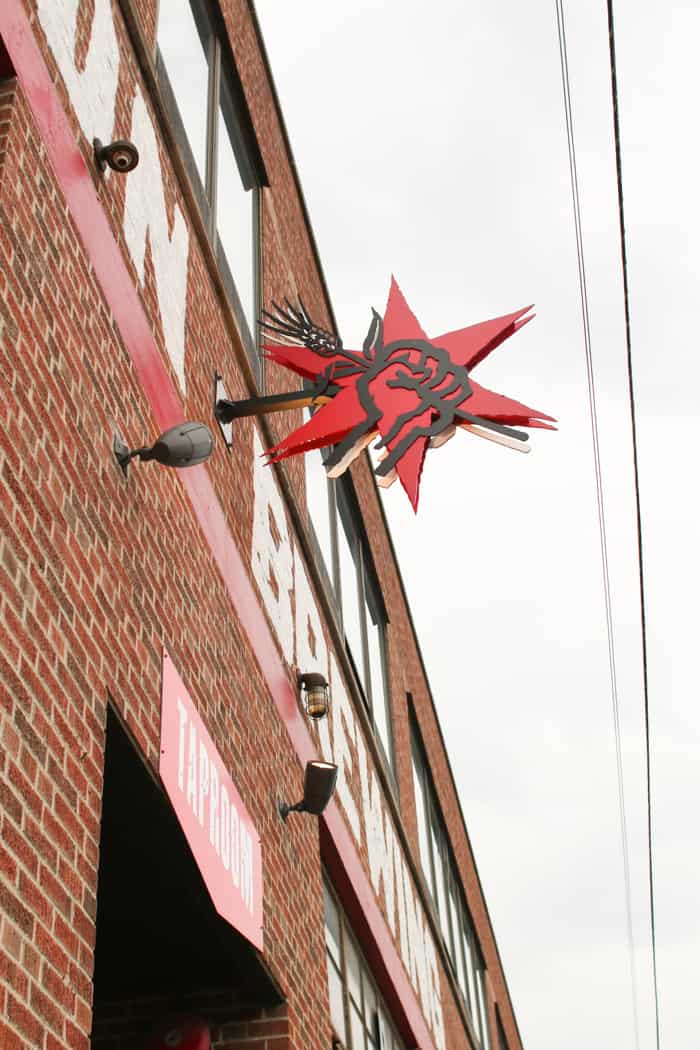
[{"x1": 0, "y1": 0, "x2": 434, "y2": 1050}]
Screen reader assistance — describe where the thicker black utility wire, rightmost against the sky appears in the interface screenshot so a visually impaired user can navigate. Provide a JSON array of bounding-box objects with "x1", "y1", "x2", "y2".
[{"x1": 608, "y1": 0, "x2": 661, "y2": 1050}]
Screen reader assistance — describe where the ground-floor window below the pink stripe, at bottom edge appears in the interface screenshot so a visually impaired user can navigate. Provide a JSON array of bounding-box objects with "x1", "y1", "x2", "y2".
[{"x1": 323, "y1": 884, "x2": 405, "y2": 1050}]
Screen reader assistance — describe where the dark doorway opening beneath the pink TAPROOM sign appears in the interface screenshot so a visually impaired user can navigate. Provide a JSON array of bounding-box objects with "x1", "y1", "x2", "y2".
[{"x1": 91, "y1": 705, "x2": 284, "y2": 1050}]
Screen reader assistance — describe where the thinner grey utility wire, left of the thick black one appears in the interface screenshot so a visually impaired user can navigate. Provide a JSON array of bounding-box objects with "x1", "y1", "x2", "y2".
[{"x1": 555, "y1": 0, "x2": 639, "y2": 1050}]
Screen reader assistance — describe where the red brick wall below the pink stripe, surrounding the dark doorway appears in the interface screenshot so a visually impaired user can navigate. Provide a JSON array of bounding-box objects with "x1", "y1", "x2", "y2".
[{"x1": 0, "y1": 69, "x2": 330, "y2": 1048}]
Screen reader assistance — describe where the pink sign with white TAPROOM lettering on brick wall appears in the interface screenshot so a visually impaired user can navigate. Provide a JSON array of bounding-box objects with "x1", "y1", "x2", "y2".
[{"x1": 160, "y1": 651, "x2": 262, "y2": 951}]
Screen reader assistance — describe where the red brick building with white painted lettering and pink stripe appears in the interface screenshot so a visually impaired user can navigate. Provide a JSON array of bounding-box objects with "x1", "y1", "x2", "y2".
[{"x1": 0, "y1": 0, "x2": 521, "y2": 1050}]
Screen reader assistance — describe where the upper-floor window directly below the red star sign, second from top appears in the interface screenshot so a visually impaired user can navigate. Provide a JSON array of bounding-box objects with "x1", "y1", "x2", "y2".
[{"x1": 304, "y1": 452, "x2": 394, "y2": 771}]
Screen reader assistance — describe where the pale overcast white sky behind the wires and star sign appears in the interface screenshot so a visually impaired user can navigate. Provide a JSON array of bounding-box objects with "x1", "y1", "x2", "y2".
[{"x1": 256, "y1": 0, "x2": 700, "y2": 1050}]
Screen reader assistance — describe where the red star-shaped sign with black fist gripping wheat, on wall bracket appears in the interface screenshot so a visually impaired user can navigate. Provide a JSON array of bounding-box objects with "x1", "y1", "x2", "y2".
[{"x1": 217, "y1": 278, "x2": 555, "y2": 510}]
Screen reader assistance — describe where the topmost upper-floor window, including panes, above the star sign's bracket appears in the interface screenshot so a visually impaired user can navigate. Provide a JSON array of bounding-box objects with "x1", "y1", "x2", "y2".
[{"x1": 156, "y1": 0, "x2": 263, "y2": 381}]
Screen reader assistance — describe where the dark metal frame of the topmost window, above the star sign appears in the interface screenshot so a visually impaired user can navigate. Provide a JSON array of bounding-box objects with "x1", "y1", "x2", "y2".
[{"x1": 154, "y1": 0, "x2": 268, "y2": 390}]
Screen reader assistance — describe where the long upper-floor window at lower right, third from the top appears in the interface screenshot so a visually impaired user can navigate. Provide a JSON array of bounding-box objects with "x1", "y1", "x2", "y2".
[{"x1": 409, "y1": 718, "x2": 491, "y2": 1050}]
